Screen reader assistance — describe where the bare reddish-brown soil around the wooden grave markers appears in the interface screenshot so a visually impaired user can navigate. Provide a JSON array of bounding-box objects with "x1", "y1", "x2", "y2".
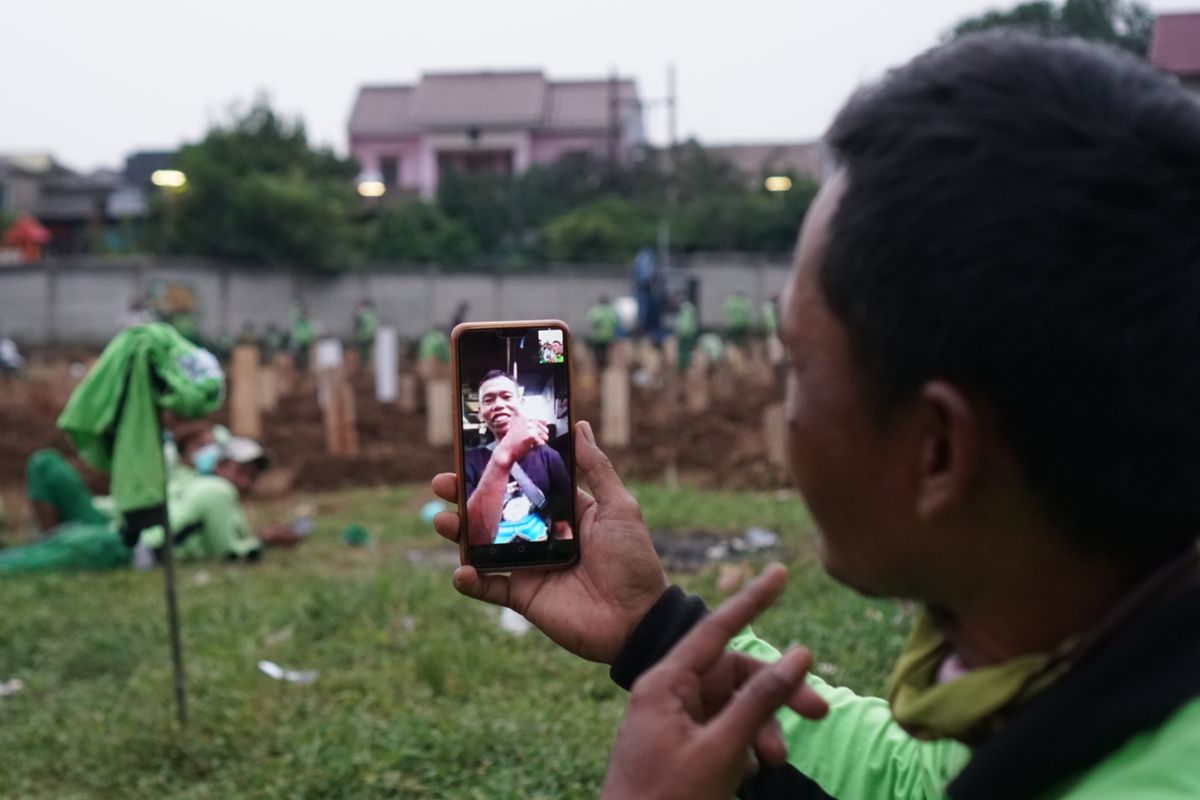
[{"x1": 0, "y1": 357, "x2": 788, "y2": 493}]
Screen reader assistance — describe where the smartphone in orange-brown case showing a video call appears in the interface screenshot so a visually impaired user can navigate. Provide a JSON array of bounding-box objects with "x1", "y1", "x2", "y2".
[{"x1": 450, "y1": 319, "x2": 580, "y2": 572}]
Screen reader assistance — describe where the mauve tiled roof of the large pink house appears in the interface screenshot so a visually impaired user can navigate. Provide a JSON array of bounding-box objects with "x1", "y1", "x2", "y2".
[{"x1": 349, "y1": 71, "x2": 637, "y2": 137}]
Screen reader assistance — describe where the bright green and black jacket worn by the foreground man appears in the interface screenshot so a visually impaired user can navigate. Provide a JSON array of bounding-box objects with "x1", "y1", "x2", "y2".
[{"x1": 611, "y1": 573, "x2": 1200, "y2": 800}]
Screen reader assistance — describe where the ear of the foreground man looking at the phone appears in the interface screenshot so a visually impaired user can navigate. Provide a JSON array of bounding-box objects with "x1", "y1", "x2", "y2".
[{"x1": 917, "y1": 380, "x2": 982, "y2": 519}]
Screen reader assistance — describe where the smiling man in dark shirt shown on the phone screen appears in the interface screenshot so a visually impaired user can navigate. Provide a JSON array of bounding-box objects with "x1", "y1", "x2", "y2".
[{"x1": 463, "y1": 369, "x2": 572, "y2": 545}]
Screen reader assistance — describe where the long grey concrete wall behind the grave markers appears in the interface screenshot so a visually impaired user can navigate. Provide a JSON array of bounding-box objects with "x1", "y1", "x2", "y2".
[{"x1": 0, "y1": 257, "x2": 787, "y2": 345}]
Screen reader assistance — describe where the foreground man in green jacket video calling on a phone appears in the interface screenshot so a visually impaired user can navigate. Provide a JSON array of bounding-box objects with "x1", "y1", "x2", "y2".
[{"x1": 433, "y1": 31, "x2": 1200, "y2": 800}]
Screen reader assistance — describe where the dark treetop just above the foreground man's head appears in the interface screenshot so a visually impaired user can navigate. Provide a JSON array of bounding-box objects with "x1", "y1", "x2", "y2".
[{"x1": 944, "y1": 0, "x2": 1154, "y2": 56}]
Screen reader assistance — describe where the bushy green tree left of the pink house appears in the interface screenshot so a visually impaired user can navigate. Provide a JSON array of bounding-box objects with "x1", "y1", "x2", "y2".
[{"x1": 157, "y1": 97, "x2": 358, "y2": 271}]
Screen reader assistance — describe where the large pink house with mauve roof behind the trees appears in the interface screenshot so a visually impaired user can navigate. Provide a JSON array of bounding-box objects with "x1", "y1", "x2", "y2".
[{"x1": 349, "y1": 72, "x2": 643, "y2": 198}]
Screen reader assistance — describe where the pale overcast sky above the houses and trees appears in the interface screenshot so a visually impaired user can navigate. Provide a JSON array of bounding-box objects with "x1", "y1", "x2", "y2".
[{"x1": 0, "y1": 0, "x2": 1200, "y2": 169}]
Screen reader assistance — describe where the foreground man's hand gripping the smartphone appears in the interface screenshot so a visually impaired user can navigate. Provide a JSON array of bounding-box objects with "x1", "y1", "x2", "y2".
[{"x1": 433, "y1": 422, "x2": 667, "y2": 663}]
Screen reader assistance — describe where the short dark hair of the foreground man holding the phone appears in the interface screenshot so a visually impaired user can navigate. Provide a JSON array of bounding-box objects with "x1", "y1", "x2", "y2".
[{"x1": 818, "y1": 32, "x2": 1200, "y2": 565}]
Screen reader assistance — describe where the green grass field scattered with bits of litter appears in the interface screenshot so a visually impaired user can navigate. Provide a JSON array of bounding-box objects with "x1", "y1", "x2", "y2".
[{"x1": 0, "y1": 486, "x2": 907, "y2": 799}]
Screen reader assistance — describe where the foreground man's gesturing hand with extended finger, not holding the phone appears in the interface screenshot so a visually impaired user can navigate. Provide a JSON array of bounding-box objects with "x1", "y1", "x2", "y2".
[{"x1": 601, "y1": 565, "x2": 828, "y2": 800}]
